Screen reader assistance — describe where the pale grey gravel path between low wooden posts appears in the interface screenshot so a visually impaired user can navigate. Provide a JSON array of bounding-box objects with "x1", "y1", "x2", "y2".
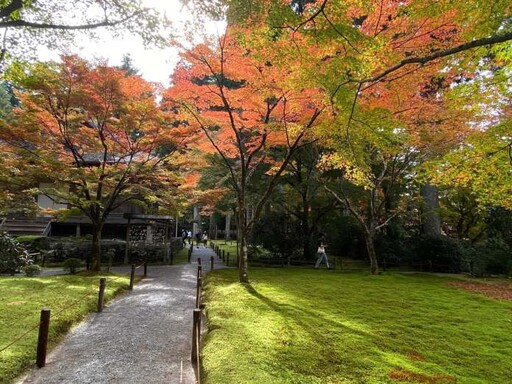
[{"x1": 18, "y1": 247, "x2": 220, "y2": 384}]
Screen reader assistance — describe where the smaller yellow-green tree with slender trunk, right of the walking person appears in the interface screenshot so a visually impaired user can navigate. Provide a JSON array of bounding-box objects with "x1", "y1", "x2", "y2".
[{"x1": 323, "y1": 112, "x2": 416, "y2": 274}]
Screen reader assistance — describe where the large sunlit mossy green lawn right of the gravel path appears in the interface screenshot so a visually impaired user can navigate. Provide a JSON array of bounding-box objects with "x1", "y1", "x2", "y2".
[{"x1": 202, "y1": 268, "x2": 512, "y2": 384}]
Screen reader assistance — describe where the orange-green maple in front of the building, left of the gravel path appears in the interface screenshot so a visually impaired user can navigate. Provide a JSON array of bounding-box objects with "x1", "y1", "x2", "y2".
[{"x1": 0, "y1": 56, "x2": 180, "y2": 270}]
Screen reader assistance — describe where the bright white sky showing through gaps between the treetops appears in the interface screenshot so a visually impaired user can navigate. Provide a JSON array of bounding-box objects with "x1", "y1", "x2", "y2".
[{"x1": 39, "y1": 0, "x2": 224, "y2": 86}]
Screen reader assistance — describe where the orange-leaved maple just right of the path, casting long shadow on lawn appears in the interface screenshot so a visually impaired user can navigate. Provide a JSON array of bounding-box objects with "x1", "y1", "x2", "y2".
[{"x1": 165, "y1": 30, "x2": 323, "y2": 282}]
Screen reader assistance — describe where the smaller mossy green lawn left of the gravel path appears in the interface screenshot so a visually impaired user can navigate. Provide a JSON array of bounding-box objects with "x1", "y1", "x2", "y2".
[{"x1": 0, "y1": 274, "x2": 129, "y2": 384}]
